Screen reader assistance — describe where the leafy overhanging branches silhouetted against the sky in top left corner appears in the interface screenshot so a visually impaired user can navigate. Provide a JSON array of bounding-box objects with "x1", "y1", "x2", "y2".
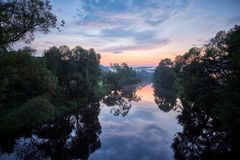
[{"x1": 0, "y1": 0, "x2": 64, "y2": 50}]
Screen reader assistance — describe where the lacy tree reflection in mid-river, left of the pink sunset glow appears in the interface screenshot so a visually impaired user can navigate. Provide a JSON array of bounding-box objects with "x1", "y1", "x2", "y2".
[{"x1": 103, "y1": 85, "x2": 141, "y2": 117}]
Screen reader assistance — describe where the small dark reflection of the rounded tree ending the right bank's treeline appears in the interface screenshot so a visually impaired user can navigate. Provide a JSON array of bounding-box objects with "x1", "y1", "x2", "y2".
[{"x1": 154, "y1": 87, "x2": 177, "y2": 112}]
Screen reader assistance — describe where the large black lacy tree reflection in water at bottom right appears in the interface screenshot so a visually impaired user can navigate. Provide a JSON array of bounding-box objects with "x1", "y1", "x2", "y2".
[{"x1": 172, "y1": 101, "x2": 229, "y2": 160}]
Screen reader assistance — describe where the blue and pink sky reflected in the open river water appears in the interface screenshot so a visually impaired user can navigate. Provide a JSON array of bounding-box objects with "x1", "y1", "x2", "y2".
[{"x1": 90, "y1": 86, "x2": 181, "y2": 160}]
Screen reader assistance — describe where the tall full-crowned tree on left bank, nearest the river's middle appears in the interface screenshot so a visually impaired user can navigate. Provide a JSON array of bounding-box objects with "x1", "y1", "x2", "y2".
[{"x1": 44, "y1": 46, "x2": 100, "y2": 100}]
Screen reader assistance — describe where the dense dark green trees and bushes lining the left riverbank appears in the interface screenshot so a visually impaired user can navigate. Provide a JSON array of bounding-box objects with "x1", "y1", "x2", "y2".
[{"x1": 0, "y1": 46, "x2": 100, "y2": 128}]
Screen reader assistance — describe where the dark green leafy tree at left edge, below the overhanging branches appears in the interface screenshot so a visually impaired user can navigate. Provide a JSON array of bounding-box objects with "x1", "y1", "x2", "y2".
[{"x1": 0, "y1": 49, "x2": 57, "y2": 105}]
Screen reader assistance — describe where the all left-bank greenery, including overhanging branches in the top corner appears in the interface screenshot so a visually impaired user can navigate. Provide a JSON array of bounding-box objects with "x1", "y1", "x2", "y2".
[{"x1": 0, "y1": 0, "x2": 101, "y2": 134}]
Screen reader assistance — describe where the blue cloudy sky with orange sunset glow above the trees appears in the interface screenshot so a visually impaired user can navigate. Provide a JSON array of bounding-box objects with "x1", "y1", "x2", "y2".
[{"x1": 21, "y1": 0, "x2": 240, "y2": 66}]
